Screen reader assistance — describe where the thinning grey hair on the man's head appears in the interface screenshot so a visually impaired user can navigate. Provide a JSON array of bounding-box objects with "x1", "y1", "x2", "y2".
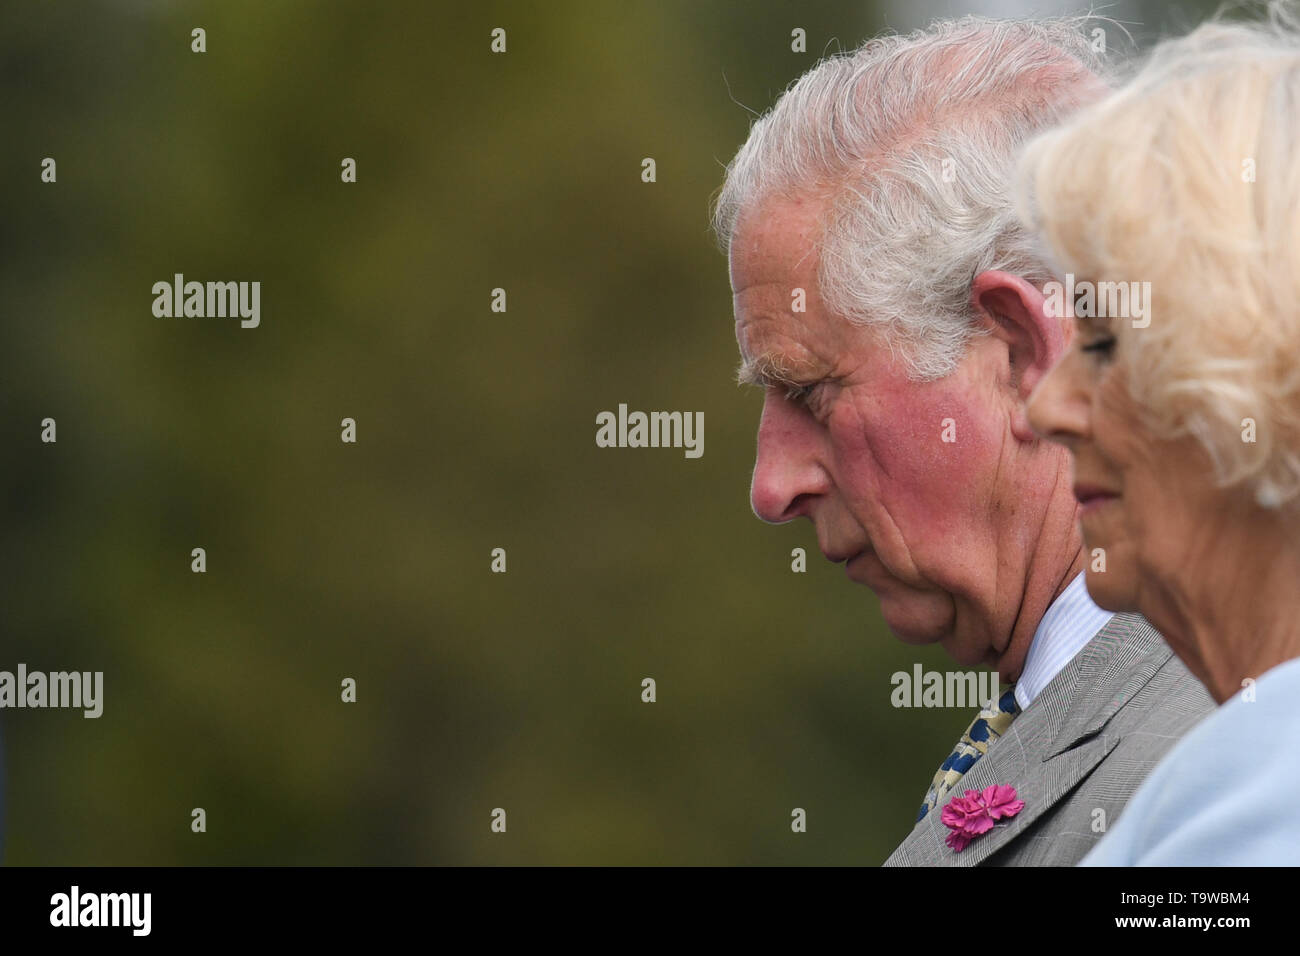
[{"x1": 712, "y1": 16, "x2": 1122, "y2": 380}]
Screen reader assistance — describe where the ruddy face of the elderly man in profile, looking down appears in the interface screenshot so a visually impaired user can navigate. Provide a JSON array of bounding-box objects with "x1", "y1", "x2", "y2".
[{"x1": 731, "y1": 200, "x2": 1055, "y2": 666}]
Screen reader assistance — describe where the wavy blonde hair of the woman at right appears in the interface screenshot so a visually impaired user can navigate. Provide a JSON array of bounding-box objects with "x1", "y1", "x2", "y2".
[{"x1": 1017, "y1": 3, "x2": 1300, "y2": 507}]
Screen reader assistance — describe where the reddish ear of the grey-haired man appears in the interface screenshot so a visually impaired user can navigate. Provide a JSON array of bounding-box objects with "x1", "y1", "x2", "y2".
[{"x1": 971, "y1": 269, "x2": 1069, "y2": 437}]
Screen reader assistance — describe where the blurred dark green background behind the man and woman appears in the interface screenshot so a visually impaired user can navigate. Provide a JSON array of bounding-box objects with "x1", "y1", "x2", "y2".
[{"x1": 0, "y1": 0, "x2": 1209, "y2": 865}]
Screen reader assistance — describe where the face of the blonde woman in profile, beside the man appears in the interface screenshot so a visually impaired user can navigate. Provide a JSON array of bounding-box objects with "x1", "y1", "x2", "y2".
[{"x1": 1028, "y1": 319, "x2": 1222, "y2": 611}]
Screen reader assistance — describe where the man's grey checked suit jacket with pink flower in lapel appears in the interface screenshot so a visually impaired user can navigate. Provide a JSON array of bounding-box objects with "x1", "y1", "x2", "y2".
[{"x1": 884, "y1": 614, "x2": 1216, "y2": 866}]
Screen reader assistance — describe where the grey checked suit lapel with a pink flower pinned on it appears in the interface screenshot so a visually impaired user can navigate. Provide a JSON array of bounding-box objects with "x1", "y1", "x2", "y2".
[{"x1": 885, "y1": 614, "x2": 1170, "y2": 866}]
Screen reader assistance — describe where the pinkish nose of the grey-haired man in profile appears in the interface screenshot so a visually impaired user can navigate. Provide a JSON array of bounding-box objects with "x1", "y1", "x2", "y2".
[{"x1": 749, "y1": 389, "x2": 831, "y2": 524}]
